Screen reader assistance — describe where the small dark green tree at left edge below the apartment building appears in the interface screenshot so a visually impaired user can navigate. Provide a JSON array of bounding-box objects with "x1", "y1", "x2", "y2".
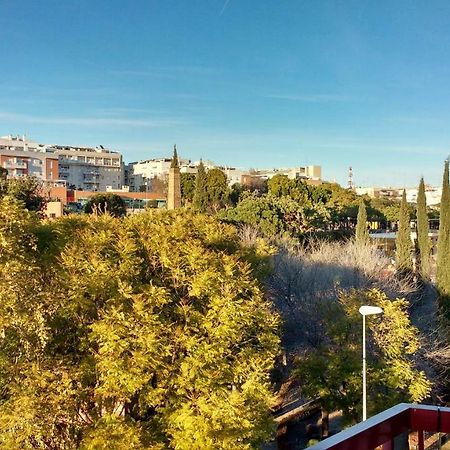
[{"x1": 0, "y1": 177, "x2": 48, "y2": 211}]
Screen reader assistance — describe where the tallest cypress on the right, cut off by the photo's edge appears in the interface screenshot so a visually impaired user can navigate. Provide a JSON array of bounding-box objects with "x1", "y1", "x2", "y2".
[{"x1": 436, "y1": 160, "x2": 450, "y2": 304}]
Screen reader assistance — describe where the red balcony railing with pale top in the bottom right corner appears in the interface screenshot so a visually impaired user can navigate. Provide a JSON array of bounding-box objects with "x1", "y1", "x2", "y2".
[{"x1": 308, "y1": 403, "x2": 450, "y2": 450}]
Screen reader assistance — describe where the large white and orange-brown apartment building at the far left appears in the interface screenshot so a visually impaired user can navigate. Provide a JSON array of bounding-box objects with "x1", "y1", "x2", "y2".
[{"x1": 0, "y1": 135, "x2": 123, "y2": 191}]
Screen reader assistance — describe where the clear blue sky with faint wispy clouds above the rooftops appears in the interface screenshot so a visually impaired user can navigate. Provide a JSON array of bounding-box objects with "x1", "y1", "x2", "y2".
[{"x1": 0, "y1": 0, "x2": 450, "y2": 185}]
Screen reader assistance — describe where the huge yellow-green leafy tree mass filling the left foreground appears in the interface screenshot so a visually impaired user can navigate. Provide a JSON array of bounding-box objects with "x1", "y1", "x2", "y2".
[{"x1": 0, "y1": 206, "x2": 279, "y2": 450}]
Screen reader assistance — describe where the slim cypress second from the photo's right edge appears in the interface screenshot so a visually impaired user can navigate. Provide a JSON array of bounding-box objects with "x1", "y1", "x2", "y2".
[{"x1": 417, "y1": 178, "x2": 431, "y2": 278}]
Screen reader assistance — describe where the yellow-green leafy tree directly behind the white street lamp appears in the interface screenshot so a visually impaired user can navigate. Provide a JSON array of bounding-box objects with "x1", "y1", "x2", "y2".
[{"x1": 295, "y1": 289, "x2": 431, "y2": 423}]
